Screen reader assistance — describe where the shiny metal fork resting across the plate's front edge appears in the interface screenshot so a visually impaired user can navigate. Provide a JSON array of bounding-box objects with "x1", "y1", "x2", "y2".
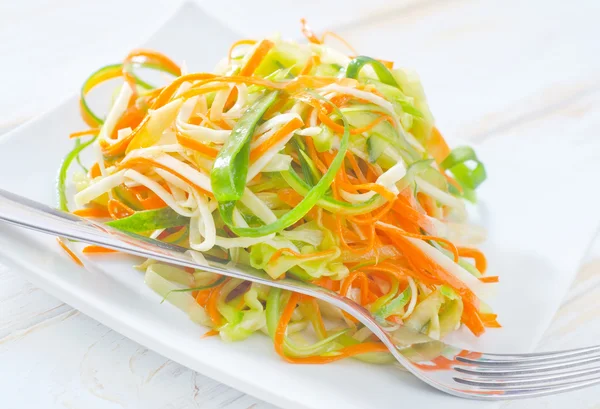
[{"x1": 0, "y1": 189, "x2": 600, "y2": 400}]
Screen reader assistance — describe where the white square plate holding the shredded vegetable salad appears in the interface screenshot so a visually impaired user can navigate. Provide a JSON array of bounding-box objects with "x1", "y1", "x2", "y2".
[{"x1": 0, "y1": 4, "x2": 600, "y2": 409}]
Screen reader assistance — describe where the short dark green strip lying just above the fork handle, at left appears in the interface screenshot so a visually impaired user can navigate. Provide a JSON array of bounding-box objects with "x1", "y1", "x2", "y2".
[{"x1": 106, "y1": 207, "x2": 190, "y2": 233}]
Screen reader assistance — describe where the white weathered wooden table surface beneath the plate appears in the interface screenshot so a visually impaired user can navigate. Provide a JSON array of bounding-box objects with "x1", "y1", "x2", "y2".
[{"x1": 0, "y1": 0, "x2": 600, "y2": 409}]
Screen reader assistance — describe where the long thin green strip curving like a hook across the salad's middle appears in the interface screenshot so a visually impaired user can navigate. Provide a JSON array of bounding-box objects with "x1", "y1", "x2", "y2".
[{"x1": 218, "y1": 96, "x2": 350, "y2": 237}]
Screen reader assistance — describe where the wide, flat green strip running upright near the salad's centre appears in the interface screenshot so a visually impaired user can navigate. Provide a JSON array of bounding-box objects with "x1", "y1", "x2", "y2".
[{"x1": 210, "y1": 91, "x2": 278, "y2": 202}]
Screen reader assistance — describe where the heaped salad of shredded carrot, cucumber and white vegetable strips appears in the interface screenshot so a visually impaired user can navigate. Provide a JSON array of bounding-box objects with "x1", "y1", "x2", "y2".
[{"x1": 58, "y1": 22, "x2": 500, "y2": 363}]
